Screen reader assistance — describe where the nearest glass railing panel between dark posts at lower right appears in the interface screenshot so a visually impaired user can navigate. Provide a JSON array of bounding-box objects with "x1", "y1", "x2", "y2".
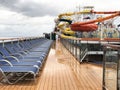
[{"x1": 105, "y1": 50, "x2": 118, "y2": 90}]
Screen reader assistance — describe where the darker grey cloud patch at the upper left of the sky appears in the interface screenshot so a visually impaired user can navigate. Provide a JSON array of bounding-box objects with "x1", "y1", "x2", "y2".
[{"x1": 0, "y1": 0, "x2": 59, "y2": 17}]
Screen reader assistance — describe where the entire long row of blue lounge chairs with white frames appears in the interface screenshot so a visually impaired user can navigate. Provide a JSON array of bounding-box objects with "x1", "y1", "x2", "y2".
[{"x1": 0, "y1": 38, "x2": 52, "y2": 84}]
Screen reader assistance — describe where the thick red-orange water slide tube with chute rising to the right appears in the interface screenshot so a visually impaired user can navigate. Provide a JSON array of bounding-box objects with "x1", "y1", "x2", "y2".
[{"x1": 70, "y1": 12, "x2": 120, "y2": 32}]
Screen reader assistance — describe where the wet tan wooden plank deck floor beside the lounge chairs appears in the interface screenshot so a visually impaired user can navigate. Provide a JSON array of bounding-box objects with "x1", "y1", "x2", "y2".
[{"x1": 0, "y1": 43, "x2": 102, "y2": 90}]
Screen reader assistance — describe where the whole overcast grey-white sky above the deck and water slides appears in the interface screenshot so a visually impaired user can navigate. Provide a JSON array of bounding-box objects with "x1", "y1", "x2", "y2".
[{"x1": 0, "y1": 0, "x2": 120, "y2": 37}]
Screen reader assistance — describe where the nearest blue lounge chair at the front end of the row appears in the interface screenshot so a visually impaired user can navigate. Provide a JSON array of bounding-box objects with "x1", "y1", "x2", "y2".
[{"x1": 0, "y1": 60, "x2": 38, "y2": 84}]
